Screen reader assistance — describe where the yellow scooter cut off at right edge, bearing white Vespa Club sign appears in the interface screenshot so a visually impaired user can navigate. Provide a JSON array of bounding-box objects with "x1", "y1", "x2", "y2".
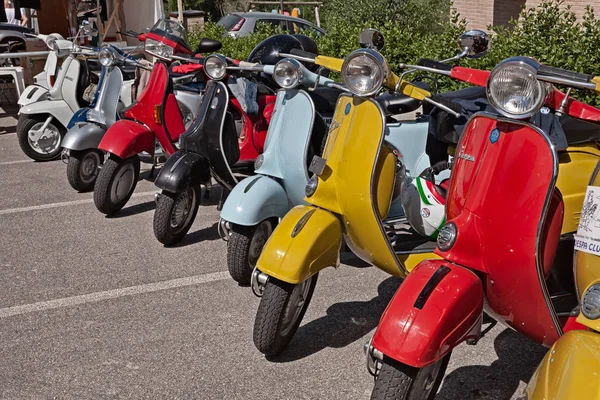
[{"x1": 519, "y1": 70, "x2": 600, "y2": 400}]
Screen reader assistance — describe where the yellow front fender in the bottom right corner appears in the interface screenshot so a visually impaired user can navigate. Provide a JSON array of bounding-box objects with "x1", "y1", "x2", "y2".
[{"x1": 526, "y1": 331, "x2": 600, "y2": 400}]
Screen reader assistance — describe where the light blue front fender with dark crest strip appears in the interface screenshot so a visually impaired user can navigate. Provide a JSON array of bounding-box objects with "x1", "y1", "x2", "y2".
[{"x1": 221, "y1": 175, "x2": 290, "y2": 226}]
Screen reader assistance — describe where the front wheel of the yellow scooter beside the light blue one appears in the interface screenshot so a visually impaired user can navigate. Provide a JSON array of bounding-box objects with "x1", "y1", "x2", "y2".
[{"x1": 254, "y1": 274, "x2": 318, "y2": 356}]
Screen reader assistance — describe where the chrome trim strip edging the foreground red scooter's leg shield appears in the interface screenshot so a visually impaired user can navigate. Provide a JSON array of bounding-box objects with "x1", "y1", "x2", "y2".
[{"x1": 468, "y1": 112, "x2": 564, "y2": 336}]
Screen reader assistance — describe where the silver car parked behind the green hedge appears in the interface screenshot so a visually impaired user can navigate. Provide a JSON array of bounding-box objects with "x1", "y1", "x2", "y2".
[{"x1": 217, "y1": 12, "x2": 325, "y2": 36}]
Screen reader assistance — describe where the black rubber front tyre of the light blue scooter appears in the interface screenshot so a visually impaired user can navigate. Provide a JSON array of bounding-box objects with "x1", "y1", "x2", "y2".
[{"x1": 227, "y1": 220, "x2": 276, "y2": 286}]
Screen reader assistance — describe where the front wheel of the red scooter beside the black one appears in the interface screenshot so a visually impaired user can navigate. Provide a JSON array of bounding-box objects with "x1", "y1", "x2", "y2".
[{"x1": 94, "y1": 154, "x2": 140, "y2": 215}]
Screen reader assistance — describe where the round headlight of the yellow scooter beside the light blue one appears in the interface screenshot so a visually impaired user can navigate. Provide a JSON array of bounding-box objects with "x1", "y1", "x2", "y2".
[{"x1": 341, "y1": 49, "x2": 390, "y2": 96}]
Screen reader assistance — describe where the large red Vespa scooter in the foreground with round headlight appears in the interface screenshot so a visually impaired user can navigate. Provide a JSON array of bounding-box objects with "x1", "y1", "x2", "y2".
[{"x1": 366, "y1": 57, "x2": 600, "y2": 399}]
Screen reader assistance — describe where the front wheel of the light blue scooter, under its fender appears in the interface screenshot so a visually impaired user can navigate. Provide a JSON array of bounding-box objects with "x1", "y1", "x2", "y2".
[{"x1": 227, "y1": 220, "x2": 275, "y2": 285}]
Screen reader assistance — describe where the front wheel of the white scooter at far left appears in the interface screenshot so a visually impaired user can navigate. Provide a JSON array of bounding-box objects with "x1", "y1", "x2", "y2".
[{"x1": 17, "y1": 114, "x2": 67, "y2": 161}]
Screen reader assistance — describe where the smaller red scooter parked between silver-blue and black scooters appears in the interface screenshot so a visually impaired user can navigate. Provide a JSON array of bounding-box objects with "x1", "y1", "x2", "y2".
[{"x1": 94, "y1": 20, "x2": 221, "y2": 215}]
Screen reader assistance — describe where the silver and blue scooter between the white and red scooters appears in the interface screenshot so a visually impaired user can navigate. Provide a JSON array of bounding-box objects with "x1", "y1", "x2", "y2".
[{"x1": 62, "y1": 46, "x2": 139, "y2": 192}]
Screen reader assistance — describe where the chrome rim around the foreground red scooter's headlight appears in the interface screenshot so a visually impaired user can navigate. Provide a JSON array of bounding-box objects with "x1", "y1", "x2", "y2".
[{"x1": 486, "y1": 56, "x2": 550, "y2": 119}]
